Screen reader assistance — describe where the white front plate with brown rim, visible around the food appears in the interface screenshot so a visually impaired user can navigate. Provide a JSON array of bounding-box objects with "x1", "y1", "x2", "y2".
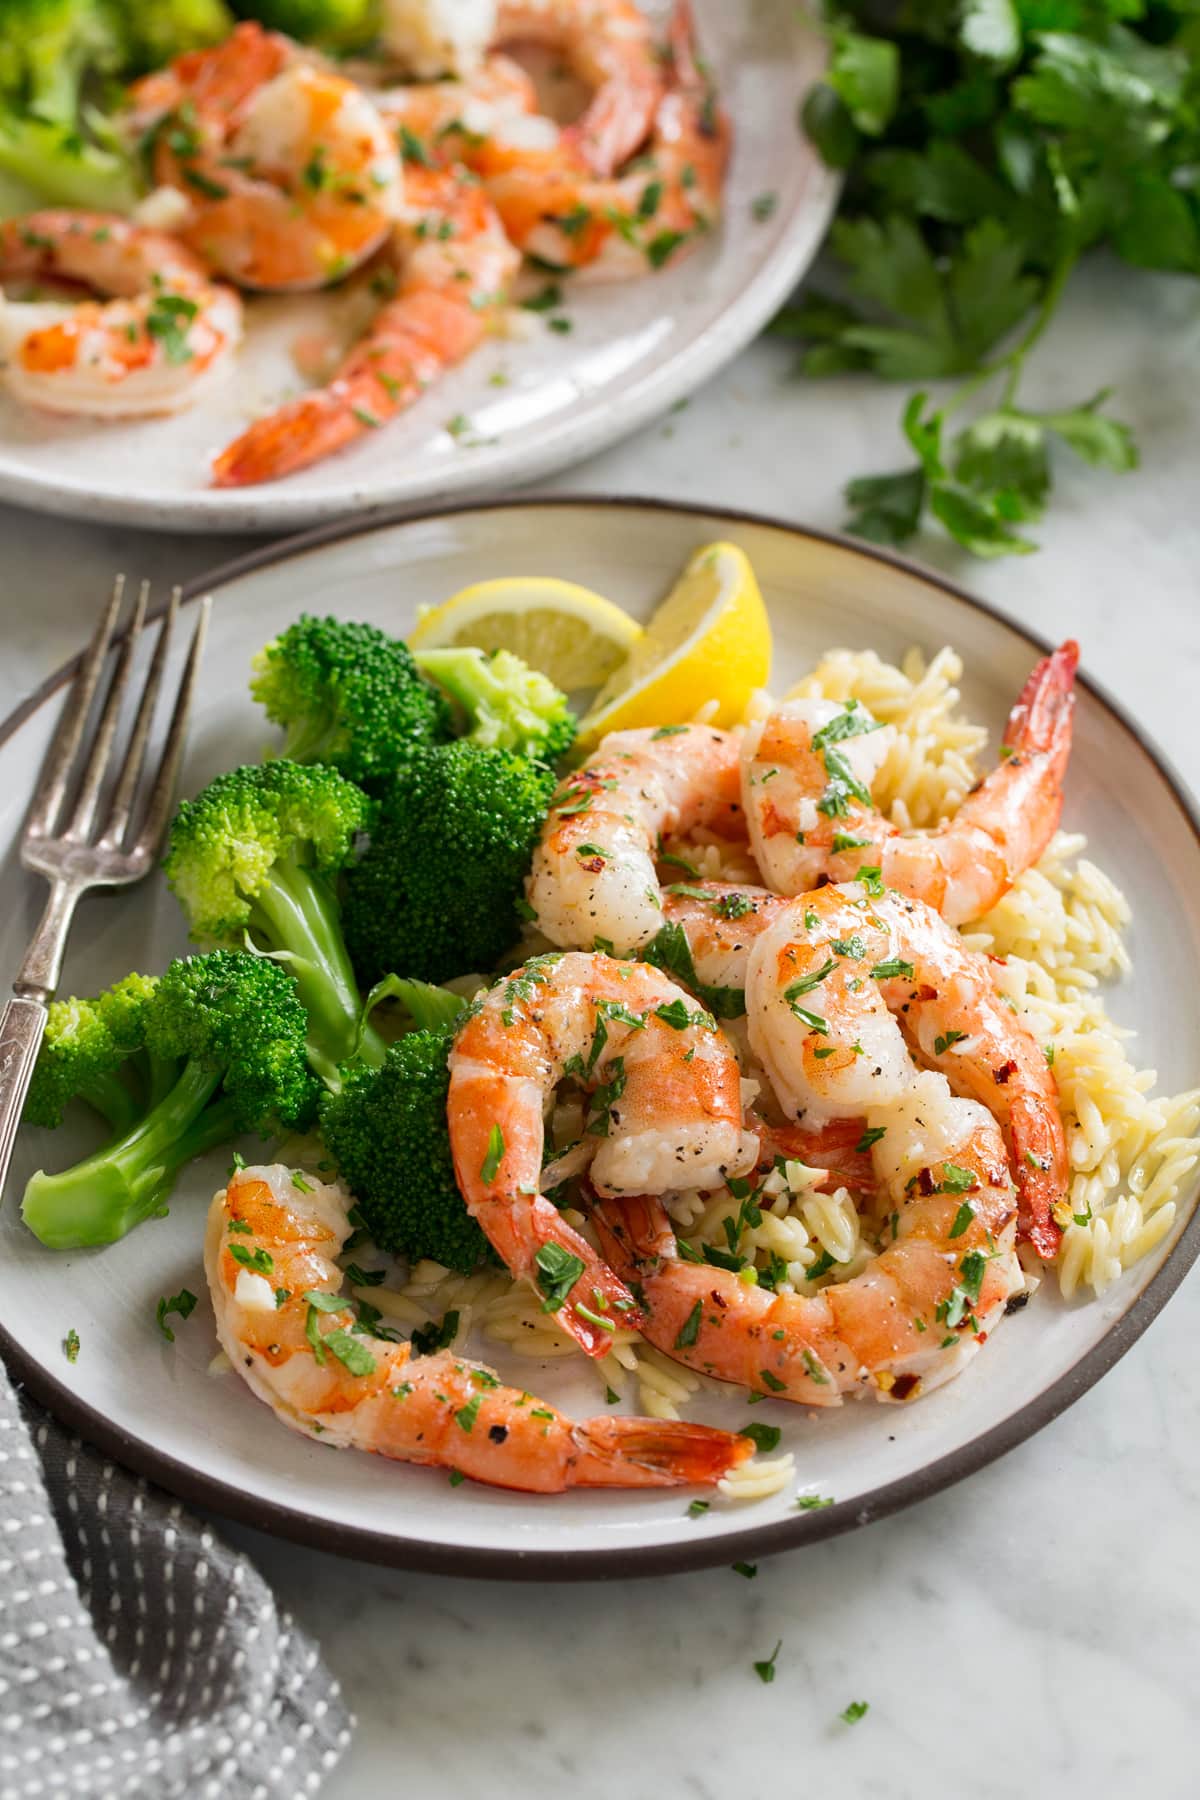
[{"x1": 0, "y1": 500, "x2": 1200, "y2": 1577}]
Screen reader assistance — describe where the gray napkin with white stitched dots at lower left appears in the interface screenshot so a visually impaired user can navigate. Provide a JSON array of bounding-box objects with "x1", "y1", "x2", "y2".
[{"x1": 0, "y1": 1370, "x2": 353, "y2": 1800}]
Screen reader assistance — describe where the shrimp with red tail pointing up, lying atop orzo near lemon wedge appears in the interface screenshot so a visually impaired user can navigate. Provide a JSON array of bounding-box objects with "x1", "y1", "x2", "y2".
[{"x1": 743, "y1": 643, "x2": 1079, "y2": 925}]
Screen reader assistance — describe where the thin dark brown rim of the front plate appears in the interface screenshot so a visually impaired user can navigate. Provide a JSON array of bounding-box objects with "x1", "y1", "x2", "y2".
[{"x1": 0, "y1": 493, "x2": 1200, "y2": 1580}]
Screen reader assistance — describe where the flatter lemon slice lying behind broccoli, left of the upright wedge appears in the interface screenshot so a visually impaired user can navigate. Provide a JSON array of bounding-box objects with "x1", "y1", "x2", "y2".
[{"x1": 408, "y1": 576, "x2": 646, "y2": 693}]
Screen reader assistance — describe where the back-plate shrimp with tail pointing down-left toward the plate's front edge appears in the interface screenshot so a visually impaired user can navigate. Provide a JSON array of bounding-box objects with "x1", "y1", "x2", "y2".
[{"x1": 212, "y1": 169, "x2": 520, "y2": 488}]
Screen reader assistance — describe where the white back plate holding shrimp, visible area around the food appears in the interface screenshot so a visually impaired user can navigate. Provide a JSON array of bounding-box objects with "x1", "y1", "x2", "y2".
[{"x1": 0, "y1": 0, "x2": 838, "y2": 531}]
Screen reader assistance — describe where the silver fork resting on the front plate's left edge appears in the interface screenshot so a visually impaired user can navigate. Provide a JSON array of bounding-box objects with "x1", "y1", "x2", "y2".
[{"x1": 0, "y1": 576, "x2": 210, "y2": 1192}]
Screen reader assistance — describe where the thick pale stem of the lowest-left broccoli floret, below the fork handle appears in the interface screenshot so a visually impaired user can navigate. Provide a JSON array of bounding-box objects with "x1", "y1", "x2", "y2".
[{"x1": 22, "y1": 1062, "x2": 237, "y2": 1249}]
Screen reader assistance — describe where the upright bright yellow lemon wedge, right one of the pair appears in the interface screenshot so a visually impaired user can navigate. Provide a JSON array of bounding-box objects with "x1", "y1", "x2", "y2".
[{"x1": 579, "y1": 544, "x2": 770, "y2": 749}]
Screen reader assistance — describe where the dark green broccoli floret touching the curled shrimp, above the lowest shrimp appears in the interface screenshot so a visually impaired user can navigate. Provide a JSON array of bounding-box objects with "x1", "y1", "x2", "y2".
[{"x1": 320, "y1": 1028, "x2": 491, "y2": 1271}]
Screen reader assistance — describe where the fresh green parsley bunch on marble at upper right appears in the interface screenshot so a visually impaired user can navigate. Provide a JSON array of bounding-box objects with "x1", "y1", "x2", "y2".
[{"x1": 772, "y1": 0, "x2": 1200, "y2": 556}]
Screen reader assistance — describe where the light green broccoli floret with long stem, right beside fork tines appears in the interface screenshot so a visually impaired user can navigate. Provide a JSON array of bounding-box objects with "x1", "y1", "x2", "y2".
[{"x1": 164, "y1": 761, "x2": 383, "y2": 1085}]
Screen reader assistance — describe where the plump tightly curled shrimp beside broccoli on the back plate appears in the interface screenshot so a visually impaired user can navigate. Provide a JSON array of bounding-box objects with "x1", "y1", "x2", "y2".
[{"x1": 131, "y1": 22, "x2": 403, "y2": 292}]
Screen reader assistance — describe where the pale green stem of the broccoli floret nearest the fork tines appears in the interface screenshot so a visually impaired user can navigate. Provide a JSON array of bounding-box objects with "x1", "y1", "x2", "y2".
[{"x1": 250, "y1": 862, "x2": 387, "y2": 1091}]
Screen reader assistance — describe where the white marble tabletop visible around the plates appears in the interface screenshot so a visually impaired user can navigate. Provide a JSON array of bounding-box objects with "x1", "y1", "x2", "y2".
[{"x1": 0, "y1": 257, "x2": 1200, "y2": 1800}]
